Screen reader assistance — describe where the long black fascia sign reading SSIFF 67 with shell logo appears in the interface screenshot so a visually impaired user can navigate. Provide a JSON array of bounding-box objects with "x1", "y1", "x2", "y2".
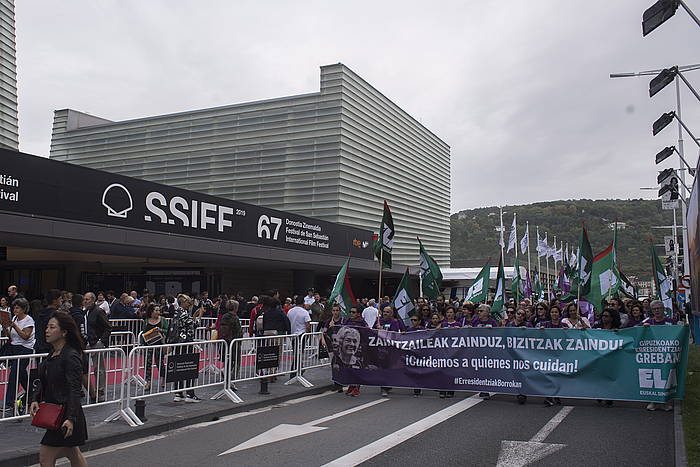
[{"x1": 0, "y1": 150, "x2": 372, "y2": 259}]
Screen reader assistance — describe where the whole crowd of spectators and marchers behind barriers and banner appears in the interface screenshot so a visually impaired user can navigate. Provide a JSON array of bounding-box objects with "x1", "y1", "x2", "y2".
[{"x1": 0, "y1": 285, "x2": 682, "y2": 430}]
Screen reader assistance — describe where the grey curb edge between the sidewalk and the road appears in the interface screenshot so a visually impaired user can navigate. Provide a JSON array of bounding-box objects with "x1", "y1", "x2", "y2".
[{"x1": 2, "y1": 384, "x2": 333, "y2": 467}]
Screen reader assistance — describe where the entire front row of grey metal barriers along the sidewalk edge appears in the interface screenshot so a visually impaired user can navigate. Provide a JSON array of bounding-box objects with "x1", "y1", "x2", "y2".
[{"x1": 0, "y1": 332, "x2": 329, "y2": 426}]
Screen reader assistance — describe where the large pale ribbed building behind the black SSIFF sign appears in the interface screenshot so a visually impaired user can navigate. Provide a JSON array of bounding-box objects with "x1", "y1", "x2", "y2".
[{"x1": 50, "y1": 63, "x2": 450, "y2": 266}]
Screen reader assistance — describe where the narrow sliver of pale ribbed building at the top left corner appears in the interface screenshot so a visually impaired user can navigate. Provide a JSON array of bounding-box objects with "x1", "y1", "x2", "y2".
[{"x1": 0, "y1": 0, "x2": 19, "y2": 150}]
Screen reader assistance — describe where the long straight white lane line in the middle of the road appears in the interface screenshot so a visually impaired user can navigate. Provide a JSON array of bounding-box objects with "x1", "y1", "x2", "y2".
[{"x1": 323, "y1": 395, "x2": 482, "y2": 467}]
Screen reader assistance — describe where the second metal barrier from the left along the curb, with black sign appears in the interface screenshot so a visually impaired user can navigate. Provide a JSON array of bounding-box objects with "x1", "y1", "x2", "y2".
[{"x1": 122, "y1": 340, "x2": 237, "y2": 425}]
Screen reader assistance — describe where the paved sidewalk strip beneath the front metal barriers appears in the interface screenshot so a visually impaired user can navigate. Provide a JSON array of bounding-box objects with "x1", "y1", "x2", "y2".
[{"x1": 0, "y1": 366, "x2": 332, "y2": 467}]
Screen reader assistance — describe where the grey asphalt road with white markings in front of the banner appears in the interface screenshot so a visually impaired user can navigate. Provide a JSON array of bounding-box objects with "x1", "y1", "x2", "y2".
[{"x1": 58, "y1": 388, "x2": 674, "y2": 467}]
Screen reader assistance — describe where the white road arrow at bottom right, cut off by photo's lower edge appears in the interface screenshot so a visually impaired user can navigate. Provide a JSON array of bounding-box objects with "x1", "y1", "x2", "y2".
[{"x1": 496, "y1": 405, "x2": 574, "y2": 467}]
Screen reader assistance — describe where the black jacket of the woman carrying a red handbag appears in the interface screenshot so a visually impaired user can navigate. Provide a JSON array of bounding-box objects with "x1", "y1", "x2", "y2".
[{"x1": 33, "y1": 346, "x2": 84, "y2": 424}]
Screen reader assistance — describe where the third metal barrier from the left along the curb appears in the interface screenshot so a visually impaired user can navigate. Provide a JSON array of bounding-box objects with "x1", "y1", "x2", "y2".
[{"x1": 217, "y1": 334, "x2": 302, "y2": 403}]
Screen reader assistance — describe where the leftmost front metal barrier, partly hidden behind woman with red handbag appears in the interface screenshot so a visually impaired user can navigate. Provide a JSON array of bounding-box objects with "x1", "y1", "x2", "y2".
[{"x1": 0, "y1": 347, "x2": 136, "y2": 426}]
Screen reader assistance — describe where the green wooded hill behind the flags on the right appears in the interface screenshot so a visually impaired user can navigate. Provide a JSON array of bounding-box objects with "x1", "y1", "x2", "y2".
[{"x1": 450, "y1": 199, "x2": 681, "y2": 280}]
